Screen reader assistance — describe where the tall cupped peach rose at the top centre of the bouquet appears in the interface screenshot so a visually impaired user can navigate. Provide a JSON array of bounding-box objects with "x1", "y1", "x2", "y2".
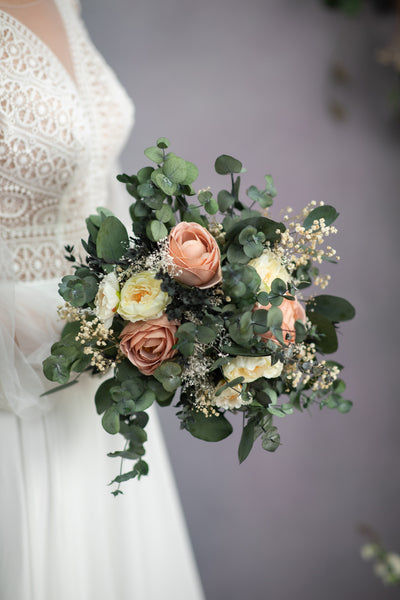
[{"x1": 169, "y1": 221, "x2": 222, "y2": 289}]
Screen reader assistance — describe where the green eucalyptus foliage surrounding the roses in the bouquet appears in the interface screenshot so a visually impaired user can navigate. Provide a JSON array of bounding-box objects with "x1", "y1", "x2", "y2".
[{"x1": 43, "y1": 138, "x2": 355, "y2": 488}]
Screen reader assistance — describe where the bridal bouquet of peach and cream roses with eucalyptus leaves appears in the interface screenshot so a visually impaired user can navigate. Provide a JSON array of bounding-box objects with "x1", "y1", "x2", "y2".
[{"x1": 44, "y1": 138, "x2": 354, "y2": 494}]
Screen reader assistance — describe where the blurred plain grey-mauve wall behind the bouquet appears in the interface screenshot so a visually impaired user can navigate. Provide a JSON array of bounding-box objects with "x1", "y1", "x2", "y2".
[{"x1": 83, "y1": 0, "x2": 400, "y2": 600}]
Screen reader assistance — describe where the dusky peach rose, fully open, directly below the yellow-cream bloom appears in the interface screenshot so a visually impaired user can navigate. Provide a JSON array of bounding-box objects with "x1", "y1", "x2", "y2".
[{"x1": 120, "y1": 314, "x2": 179, "y2": 375}]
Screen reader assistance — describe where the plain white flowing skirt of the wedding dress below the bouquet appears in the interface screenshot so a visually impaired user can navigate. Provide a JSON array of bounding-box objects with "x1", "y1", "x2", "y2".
[{"x1": 0, "y1": 284, "x2": 203, "y2": 600}]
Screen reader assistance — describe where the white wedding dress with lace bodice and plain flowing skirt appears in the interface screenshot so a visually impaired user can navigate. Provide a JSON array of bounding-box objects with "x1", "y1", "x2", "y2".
[{"x1": 0, "y1": 0, "x2": 203, "y2": 600}]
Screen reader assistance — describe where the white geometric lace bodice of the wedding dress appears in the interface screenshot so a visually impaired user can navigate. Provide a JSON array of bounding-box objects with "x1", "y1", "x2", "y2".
[{"x1": 0, "y1": 0, "x2": 133, "y2": 280}]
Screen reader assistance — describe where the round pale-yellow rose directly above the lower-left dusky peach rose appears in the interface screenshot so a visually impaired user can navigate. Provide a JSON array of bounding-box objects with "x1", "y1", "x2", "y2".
[{"x1": 118, "y1": 271, "x2": 170, "y2": 323}]
